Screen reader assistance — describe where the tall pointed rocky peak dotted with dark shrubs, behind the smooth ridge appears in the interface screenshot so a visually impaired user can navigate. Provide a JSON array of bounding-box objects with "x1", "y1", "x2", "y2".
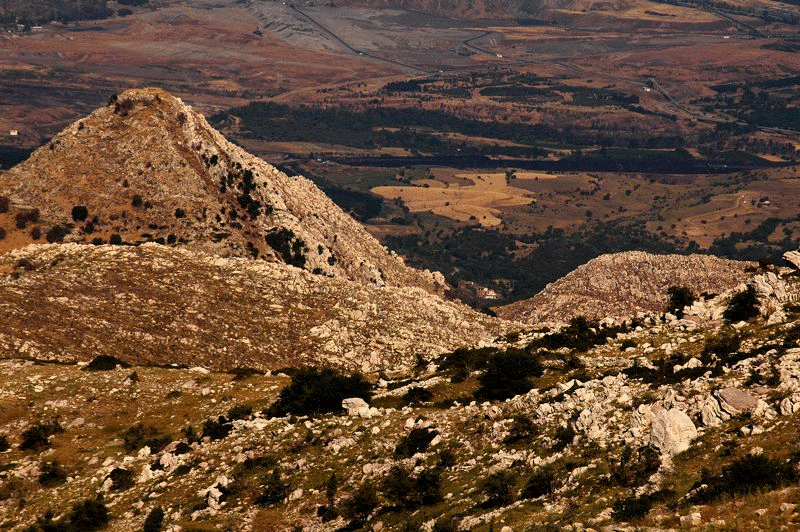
[{"x1": 0, "y1": 88, "x2": 444, "y2": 292}]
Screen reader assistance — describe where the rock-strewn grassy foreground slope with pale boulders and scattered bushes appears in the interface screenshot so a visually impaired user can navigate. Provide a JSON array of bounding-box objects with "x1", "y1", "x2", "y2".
[{"x1": 0, "y1": 256, "x2": 800, "y2": 532}]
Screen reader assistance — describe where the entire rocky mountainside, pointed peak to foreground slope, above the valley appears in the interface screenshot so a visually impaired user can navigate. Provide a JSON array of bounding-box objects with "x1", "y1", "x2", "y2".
[{"x1": 0, "y1": 89, "x2": 800, "y2": 532}]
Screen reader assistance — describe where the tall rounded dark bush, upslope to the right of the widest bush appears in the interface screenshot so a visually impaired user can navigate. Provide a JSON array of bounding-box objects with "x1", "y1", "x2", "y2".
[{"x1": 475, "y1": 348, "x2": 543, "y2": 401}]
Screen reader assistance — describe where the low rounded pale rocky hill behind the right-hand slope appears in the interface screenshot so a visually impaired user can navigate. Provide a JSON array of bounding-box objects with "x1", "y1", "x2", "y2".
[{"x1": 496, "y1": 251, "x2": 751, "y2": 324}]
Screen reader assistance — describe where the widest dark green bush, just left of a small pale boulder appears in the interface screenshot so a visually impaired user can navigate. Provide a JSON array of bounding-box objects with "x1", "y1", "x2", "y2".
[{"x1": 267, "y1": 368, "x2": 372, "y2": 417}]
